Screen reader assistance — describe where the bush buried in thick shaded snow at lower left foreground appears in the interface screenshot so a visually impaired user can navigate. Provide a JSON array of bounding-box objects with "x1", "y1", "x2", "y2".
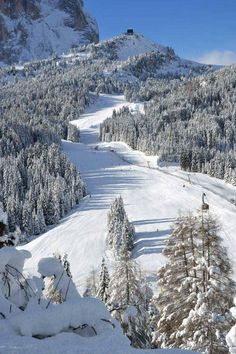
[{"x1": 0, "y1": 247, "x2": 119, "y2": 338}]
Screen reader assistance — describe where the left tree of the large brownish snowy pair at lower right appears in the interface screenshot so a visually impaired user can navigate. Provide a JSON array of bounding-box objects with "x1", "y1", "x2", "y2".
[{"x1": 153, "y1": 216, "x2": 197, "y2": 348}]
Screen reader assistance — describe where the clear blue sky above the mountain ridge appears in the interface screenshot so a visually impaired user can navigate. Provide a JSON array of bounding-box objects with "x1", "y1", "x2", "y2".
[{"x1": 85, "y1": 0, "x2": 236, "y2": 64}]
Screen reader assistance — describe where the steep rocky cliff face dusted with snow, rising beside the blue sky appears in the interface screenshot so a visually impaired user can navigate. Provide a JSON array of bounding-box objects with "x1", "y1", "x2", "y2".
[{"x1": 0, "y1": 0, "x2": 99, "y2": 64}]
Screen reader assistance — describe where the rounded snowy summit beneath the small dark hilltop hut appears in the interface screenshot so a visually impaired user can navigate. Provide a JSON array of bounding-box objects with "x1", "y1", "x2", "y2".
[{"x1": 75, "y1": 32, "x2": 209, "y2": 79}]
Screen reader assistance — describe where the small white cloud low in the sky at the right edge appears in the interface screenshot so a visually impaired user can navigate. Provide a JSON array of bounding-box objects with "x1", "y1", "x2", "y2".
[{"x1": 197, "y1": 50, "x2": 236, "y2": 65}]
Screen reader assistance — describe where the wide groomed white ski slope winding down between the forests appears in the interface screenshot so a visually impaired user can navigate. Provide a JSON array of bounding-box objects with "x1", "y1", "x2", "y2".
[{"x1": 24, "y1": 95, "x2": 236, "y2": 293}]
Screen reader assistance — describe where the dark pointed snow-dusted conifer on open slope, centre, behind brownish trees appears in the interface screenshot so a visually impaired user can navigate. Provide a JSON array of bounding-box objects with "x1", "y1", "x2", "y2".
[{"x1": 107, "y1": 196, "x2": 135, "y2": 255}]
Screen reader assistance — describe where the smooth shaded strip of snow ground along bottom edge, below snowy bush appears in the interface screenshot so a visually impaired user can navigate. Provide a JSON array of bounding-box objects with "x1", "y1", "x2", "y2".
[{"x1": 0, "y1": 333, "x2": 197, "y2": 354}]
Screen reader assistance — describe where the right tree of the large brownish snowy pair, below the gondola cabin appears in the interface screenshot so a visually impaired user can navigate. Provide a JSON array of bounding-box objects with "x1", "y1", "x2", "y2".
[{"x1": 179, "y1": 213, "x2": 235, "y2": 354}]
